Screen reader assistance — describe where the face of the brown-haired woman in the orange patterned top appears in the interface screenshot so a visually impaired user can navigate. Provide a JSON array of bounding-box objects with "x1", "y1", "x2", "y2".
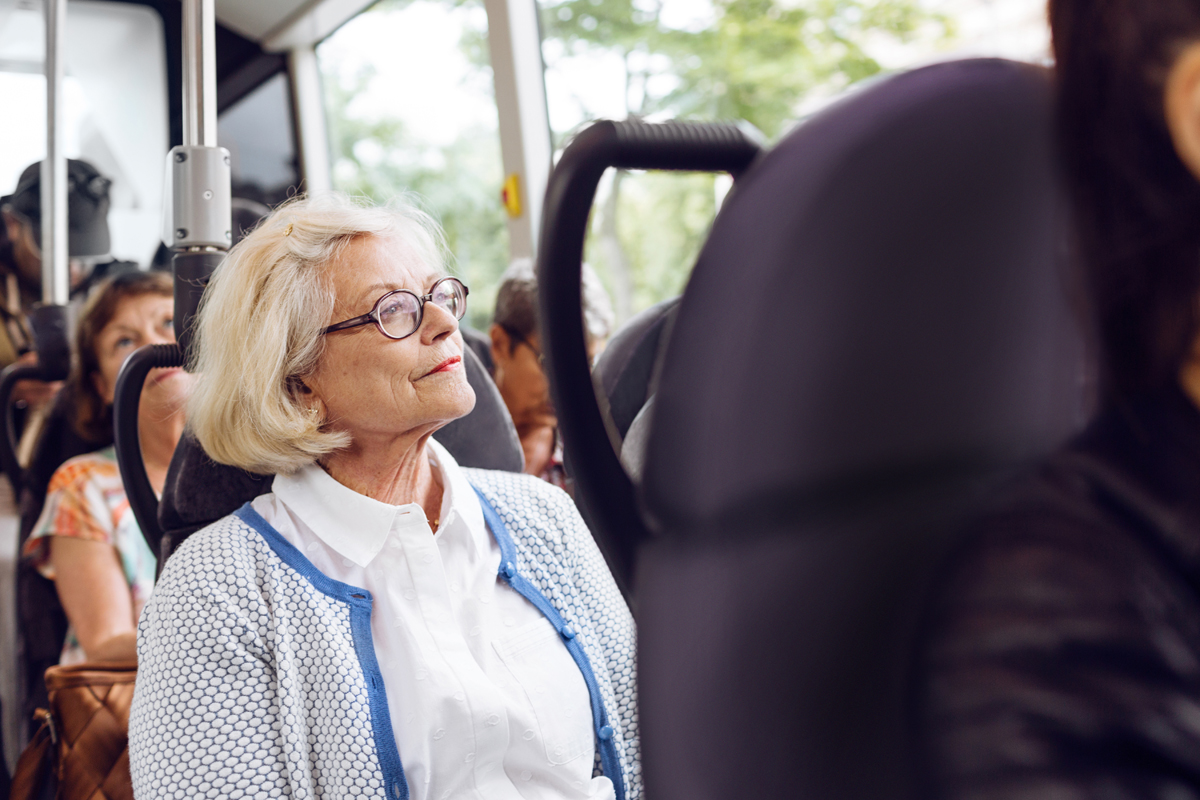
[{"x1": 92, "y1": 294, "x2": 192, "y2": 410}]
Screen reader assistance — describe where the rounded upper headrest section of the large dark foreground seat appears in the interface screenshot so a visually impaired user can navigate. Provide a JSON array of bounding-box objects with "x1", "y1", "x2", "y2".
[{"x1": 646, "y1": 60, "x2": 1082, "y2": 537}]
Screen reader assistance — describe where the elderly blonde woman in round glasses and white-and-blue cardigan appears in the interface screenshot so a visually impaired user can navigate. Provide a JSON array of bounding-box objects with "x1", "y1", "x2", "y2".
[{"x1": 130, "y1": 196, "x2": 641, "y2": 800}]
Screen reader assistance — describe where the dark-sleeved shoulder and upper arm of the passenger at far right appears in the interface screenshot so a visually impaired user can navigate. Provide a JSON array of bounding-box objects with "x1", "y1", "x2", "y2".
[{"x1": 922, "y1": 438, "x2": 1200, "y2": 794}]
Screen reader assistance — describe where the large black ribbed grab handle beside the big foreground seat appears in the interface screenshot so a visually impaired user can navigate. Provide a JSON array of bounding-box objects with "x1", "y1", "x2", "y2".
[{"x1": 538, "y1": 120, "x2": 762, "y2": 600}]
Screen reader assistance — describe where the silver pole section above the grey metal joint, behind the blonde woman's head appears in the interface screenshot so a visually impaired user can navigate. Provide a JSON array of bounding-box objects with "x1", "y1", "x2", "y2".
[{"x1": 184, "y1": 0, "x2": 217, "y2": 148}]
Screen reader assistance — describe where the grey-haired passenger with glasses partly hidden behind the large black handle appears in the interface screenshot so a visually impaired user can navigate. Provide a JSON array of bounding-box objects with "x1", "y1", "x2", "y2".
[{"x1": 490, "y1": 259, "x2": 613, "y2": 491}]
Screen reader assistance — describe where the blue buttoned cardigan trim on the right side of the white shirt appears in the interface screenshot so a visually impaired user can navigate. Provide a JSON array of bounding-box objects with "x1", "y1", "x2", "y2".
[{"x1": 470, "y1": 483, "x2": 625, "y2": 800}]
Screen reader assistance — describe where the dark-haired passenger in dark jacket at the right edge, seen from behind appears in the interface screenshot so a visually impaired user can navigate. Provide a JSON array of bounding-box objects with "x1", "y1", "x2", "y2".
[{"x1": 922, "y1": 0, "x2": 1200, "y2": 799}]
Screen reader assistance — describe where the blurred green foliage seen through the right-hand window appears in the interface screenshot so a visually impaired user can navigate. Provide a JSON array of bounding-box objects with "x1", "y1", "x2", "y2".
[{"x1": 541, "y1": 0, "x2": 954, "y2": 318}]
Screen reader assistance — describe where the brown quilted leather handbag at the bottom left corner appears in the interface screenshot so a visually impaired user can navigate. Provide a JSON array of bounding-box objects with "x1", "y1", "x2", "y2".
[{"x1": 8, "y1": 662, "x2": 137, "y2": 800}]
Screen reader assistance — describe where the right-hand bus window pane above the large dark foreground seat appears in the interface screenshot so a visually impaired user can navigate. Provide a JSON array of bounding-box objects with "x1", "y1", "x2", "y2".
[{"x1": 540, "y1": 0, "x2": 1049, "y2": 323}]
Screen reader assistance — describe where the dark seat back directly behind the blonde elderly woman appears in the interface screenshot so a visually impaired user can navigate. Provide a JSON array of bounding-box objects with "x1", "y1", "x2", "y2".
[{"x1": 150, "y1": 348, "x2": 524, "y2": 563}]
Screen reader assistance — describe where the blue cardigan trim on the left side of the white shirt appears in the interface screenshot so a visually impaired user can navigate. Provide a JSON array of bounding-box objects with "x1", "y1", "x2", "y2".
[{"x1": 234, "y1": 503, "x2": 408, "y2": 800}]
